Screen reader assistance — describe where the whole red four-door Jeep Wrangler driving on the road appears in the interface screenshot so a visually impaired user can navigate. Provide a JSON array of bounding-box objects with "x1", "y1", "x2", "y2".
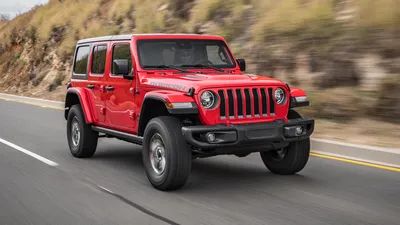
[{"x1": 65, "y1": 34, "x2": 314, "y2": 190}]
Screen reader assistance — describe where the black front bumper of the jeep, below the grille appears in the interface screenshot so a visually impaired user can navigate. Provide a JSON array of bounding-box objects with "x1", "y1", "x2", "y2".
[{"x1": 182, "y1": 119, "x2": 314, "y2": 152}]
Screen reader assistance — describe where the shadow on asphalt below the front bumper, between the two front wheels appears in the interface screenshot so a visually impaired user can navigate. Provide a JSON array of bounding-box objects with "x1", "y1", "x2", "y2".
[{"x1": 182, "y1": 156, "x2": 313, "y2": 192}]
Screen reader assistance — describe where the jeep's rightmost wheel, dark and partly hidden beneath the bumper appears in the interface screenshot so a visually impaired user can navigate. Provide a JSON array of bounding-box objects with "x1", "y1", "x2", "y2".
[{"x1": 260, "y1": 138, "x2": 310, "y2": 175}]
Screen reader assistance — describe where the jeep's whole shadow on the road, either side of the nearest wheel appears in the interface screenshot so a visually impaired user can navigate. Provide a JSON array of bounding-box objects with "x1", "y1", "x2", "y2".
[{"x1": 90, "y1": 146, "x2": 313, "y2": 193}]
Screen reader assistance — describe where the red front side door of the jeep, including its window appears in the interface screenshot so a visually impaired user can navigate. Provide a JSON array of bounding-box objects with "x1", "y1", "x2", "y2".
[{"x1": 105, "y1": 42, "x2": 136, "y2": 132}]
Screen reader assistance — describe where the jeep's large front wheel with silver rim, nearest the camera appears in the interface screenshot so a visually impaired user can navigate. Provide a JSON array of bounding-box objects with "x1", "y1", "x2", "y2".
[{"x1": 142, "y1": 116, "x2": 192, "y2": 191}]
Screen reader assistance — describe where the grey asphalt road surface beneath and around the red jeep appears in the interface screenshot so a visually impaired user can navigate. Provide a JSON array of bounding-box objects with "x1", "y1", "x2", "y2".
[{"x1": 0, "y1": 100, "x2": 400, "y2": 225}]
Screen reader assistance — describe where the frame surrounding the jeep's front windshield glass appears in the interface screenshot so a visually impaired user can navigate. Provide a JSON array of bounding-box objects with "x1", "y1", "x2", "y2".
[{"x1": 135, "y1": 38, "x2": 237, "y2": 70}]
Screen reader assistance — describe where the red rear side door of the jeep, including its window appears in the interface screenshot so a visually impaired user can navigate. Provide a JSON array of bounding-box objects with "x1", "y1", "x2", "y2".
[{"x1": 87, "y1": 42, "x2": 109, "y2": 125}]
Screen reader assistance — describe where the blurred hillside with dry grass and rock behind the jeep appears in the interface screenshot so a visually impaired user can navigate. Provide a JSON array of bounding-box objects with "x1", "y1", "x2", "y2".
[{"x1": 0, "y1": 0, "x2": 400, "y2": 146}]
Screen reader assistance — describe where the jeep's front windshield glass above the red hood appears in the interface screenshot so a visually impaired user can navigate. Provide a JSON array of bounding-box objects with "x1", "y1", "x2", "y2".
[{"x1": 137, "y1": 39, "x2": 235, "y2": 69}]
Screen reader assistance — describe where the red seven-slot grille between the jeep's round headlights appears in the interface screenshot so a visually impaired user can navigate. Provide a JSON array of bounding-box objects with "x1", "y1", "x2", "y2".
[{"x1": 218, "y1": 88, "x2": 275, "y2": 119}]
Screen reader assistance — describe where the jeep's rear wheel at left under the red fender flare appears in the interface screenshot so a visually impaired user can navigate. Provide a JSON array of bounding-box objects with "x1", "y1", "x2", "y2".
[{"x1": 67, "y1": 105, "x2": 98, "y2": 158}]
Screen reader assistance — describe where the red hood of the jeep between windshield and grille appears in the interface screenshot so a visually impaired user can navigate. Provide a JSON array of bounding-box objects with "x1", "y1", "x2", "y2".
[{"x1": 141, "y1": 73, "x2": 285, "y2": 94}]
